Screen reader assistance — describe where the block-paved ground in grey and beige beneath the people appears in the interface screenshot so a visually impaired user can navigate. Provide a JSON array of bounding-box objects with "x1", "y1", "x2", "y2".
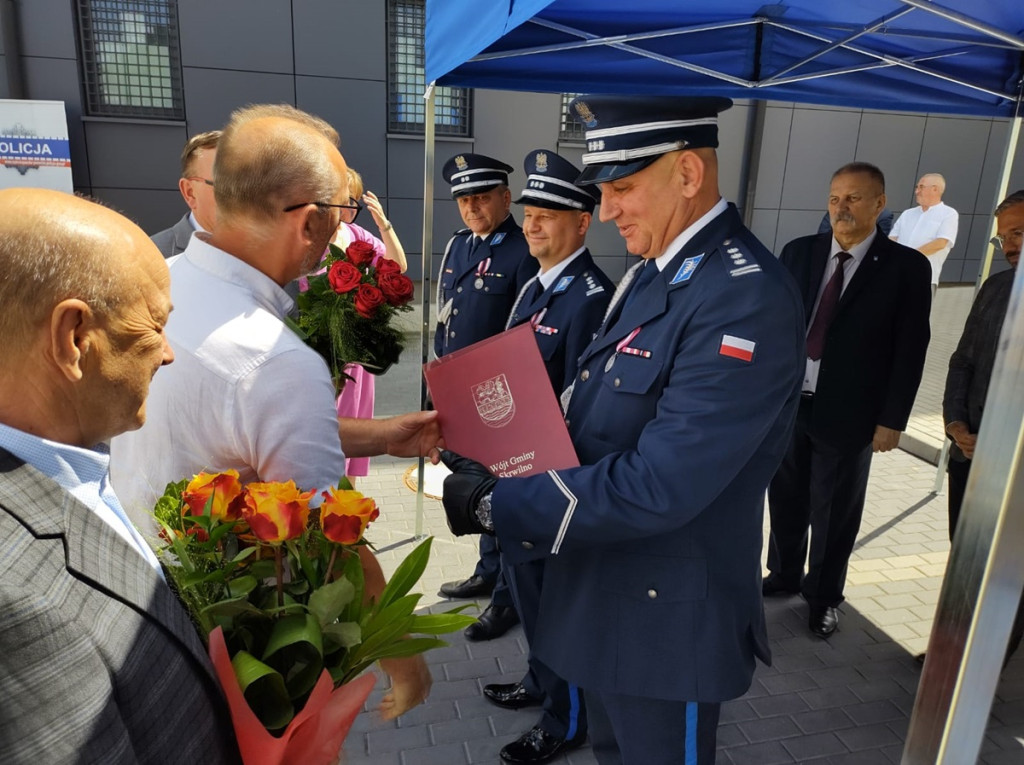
[{"x1": 343, "y1": 288, "x2": 1024, "y2": 765}]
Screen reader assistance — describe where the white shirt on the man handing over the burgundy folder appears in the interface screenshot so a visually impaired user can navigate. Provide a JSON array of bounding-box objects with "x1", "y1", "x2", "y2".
[{"x1": 111, "y1": 235, "x2": 345, "y2": 530}]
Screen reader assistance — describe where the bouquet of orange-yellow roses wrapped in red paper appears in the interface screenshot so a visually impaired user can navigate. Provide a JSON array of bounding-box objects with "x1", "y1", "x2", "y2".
[{"x1": 154, "y1": 470, "x2": 474, "y2": 765}]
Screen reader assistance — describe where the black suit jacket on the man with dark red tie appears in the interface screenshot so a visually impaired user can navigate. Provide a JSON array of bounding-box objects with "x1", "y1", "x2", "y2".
[{"x1": 780, "y1": 229, "x2": 932, "y2": 451}]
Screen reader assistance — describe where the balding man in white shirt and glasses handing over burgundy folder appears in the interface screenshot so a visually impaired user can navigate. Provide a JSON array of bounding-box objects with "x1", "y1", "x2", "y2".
[{"x1": 111, "y1": 105, "x2": 439, "y2": 717}]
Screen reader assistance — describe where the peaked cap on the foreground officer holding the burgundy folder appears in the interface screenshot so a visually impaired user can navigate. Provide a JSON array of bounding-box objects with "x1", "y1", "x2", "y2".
[{"x1": 569, "y1": 95, "x2": 732, "y2": 185}]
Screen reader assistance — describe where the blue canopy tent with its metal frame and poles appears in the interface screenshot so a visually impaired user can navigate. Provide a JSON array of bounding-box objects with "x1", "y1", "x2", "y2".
[{"x1": 421, "y1": 0, "x2": 1024, "y2": 765}]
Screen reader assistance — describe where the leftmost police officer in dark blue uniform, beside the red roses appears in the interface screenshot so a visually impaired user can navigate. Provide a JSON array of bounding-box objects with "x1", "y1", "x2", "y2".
[{"x1": 434, "y1": 154, "x2": 538, "y2": 640}]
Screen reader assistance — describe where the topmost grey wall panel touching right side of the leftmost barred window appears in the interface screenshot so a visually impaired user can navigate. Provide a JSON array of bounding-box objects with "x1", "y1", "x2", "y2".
[{"x1": 178, "y1": 0, "x2": 294, "y2": 73}]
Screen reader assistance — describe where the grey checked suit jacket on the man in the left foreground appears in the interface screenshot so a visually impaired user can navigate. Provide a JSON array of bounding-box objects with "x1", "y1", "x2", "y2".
[{"x1": 0, "y1": 450, "x2": 239, "y2": 765}]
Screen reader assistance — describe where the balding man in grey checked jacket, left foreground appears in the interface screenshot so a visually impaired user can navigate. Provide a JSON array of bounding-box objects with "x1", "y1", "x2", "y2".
[{"x1": 0, "y1": 188, "x2": 238, "y2": 765}]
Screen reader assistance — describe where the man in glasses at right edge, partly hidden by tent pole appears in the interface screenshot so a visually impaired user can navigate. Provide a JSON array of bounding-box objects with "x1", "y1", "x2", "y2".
[{"x1": 942, "y1": 188, "x2": 1024, "y2": 569}]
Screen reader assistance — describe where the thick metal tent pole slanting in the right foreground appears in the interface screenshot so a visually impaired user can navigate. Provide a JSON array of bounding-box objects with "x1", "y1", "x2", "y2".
[{"x1": 901, "y1": 260, "x2": 1024, "y2": 765}]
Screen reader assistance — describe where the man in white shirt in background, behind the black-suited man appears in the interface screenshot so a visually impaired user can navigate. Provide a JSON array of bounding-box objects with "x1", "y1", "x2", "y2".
[{"x1": 889, "y1": 173, "x2": 959, "y2": 298}]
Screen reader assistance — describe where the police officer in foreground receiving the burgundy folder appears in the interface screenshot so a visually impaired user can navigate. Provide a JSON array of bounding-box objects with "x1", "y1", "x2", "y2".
[{"x1": 443, "y1": 96, "x2": 805, "y2": 765}]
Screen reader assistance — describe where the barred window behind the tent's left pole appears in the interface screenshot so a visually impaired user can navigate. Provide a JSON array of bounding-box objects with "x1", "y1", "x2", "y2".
[{"x1": 387, "y1": 0, "x2": 472, "y2": 136}]
